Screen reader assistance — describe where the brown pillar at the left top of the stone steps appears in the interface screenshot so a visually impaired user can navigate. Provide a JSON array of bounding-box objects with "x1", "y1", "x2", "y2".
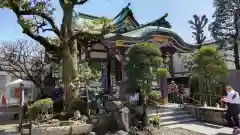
[{"x1": 159, "y1": 76, "x2": 168, "y2": 104}]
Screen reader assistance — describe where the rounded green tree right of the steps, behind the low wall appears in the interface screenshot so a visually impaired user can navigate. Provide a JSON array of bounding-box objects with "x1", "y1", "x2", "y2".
[{"x1": 189, "y1": 46, "x2": 228, "y2": 92}]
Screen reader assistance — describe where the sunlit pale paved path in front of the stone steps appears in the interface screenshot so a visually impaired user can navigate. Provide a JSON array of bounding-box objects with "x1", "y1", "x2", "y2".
[{"x1": 167, "y1": 121, "x2": 233, "y2": 135}]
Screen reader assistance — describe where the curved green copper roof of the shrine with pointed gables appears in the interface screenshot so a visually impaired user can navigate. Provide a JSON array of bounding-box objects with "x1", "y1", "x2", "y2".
[{"x1": 73, "y1": 3, "x2": 197, "y2": 49}]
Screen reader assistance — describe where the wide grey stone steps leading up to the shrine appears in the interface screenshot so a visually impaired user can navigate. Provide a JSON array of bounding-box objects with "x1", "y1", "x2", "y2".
[{"x1": 148, "y1": 106, "x2": 197, "y2": 126}]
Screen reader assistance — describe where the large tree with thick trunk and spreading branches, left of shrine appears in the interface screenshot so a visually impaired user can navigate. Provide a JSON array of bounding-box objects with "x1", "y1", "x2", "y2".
[{"x1": 0, "y1": 0, "x2": 113, "y2": 108}]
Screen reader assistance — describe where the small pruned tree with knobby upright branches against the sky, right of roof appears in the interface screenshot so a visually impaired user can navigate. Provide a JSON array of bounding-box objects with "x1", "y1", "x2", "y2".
[{"x1": 188, "y1": 14, "x2": 208, "y2": 48}]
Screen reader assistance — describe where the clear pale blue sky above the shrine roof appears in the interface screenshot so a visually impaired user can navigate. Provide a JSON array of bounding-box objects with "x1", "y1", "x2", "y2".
[{"x1": 0, "y1": 0, "x2": 214, "y2": 43}]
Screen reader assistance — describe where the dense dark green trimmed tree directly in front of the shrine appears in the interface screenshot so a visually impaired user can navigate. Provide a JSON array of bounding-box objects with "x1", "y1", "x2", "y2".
[{"x1": 125, "y1": 43, "x2": 162, "y2": 94}]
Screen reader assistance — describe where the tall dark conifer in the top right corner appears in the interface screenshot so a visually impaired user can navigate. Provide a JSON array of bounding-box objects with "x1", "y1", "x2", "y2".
[{"x1": 209, "y1": 0, "x2": 240, "y2": 69}]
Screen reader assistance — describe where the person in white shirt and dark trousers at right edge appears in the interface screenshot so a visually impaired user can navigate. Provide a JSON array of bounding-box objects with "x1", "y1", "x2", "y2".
[{"x1": 221, "y1": 86, "x2": 240, "y2": 134}]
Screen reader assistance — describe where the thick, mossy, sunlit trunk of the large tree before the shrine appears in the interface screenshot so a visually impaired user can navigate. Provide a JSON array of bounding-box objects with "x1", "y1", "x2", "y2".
[{"x1": 60, "y1": 1, "x2": 78, "y2": 112}]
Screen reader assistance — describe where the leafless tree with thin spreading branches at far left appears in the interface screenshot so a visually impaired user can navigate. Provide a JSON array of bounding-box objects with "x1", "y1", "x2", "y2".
[{"x1": 0, "y1": 40, "x2": 52, "y2": 93}]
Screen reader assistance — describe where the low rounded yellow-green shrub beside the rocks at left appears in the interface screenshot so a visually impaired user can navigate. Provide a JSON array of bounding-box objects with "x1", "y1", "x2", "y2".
[{"x1": 28, "y1": 98, "x2": 53, "y2": 120}]
